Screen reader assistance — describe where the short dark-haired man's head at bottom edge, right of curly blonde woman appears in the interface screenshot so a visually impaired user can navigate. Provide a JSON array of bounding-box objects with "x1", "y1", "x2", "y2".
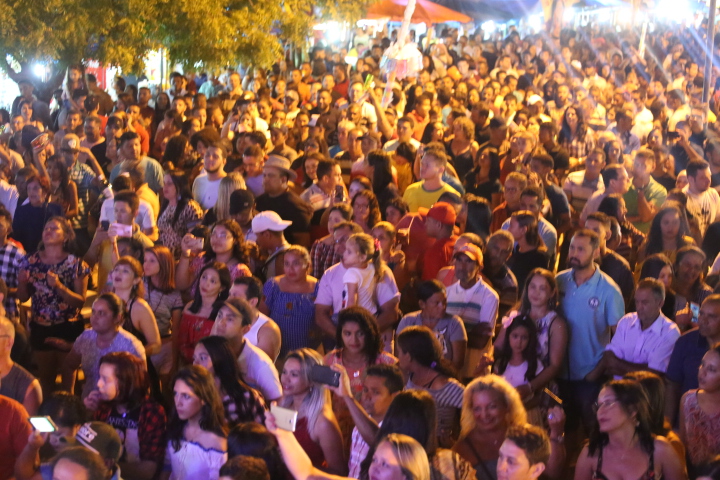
[{"x1": 497, "y1": 424, "x2": 561, "y2": 480}]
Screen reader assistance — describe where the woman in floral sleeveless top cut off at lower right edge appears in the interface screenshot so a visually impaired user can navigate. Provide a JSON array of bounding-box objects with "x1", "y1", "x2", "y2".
[{"x1": 679, "y1": 346, "x2": 720, "y2": 476}]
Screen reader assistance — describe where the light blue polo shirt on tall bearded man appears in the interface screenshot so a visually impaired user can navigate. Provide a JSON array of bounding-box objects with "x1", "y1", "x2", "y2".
[{"x1": 556, "y1": 266, "x2": 625, "y2": 380}]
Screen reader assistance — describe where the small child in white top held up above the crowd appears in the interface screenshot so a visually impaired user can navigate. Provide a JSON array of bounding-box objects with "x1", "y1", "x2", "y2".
[{"x1": 343, "y1": 233, "x2": 384, "y2": 313}]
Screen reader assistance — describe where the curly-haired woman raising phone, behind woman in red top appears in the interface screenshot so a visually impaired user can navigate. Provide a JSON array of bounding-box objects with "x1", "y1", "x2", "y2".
[{"x1": 176, "y1": 219, "x2": 252, "y2": 293}]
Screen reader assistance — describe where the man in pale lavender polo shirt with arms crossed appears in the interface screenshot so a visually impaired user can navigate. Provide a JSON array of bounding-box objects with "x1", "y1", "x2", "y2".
[{"x1": 585, "y1": 278, "x2": 680, "y2": 380}]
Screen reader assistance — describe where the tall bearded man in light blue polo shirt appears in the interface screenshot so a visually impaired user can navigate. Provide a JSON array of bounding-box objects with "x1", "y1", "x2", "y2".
[{"x1": 557, "y1": 229, "x2": 625, "y2": 431}]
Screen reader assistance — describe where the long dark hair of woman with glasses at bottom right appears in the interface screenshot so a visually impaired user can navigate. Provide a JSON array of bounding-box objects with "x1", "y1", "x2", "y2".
[{"x1": 588, "y1": 379, "x2": 655, "y2": 455}]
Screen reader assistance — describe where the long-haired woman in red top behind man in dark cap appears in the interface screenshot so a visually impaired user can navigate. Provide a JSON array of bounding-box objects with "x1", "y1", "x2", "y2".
[{"x1": 173, "y1": 262, "x2": 232, "y2": 364}]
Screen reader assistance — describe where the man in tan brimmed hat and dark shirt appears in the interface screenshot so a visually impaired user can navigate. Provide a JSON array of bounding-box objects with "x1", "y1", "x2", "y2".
[{"x1": 253, "y1": 155, "x2": 312, "y2": 248}]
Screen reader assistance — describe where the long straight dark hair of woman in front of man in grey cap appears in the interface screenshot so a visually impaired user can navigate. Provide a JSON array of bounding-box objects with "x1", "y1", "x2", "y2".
[{"x1": 198, "y1": 335, "x2": 264, "y2": 423}]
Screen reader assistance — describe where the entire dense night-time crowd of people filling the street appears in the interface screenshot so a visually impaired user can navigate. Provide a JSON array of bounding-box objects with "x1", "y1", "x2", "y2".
[{"x1": 0, "y1": 17, "x2": 720, "y2": 480}]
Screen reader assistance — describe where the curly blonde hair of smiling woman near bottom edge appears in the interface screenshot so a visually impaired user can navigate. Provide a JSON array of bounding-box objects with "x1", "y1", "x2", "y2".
[{"x1": 460, "y1": 374, "x2": 527, "y2": 437}]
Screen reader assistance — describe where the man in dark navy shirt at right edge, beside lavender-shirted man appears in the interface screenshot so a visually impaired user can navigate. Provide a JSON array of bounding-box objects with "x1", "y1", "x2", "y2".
[{"x1": 665, "y1": 294, "x2": 720, "y2": 424}]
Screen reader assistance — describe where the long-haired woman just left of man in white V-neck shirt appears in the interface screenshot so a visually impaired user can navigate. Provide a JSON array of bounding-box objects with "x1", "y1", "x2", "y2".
[{"x1": 638, "y1": 202, "x2": 695, "y2": 262}]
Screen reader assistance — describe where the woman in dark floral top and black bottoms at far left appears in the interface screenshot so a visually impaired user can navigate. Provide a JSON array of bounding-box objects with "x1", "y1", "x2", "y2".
[{"x1": 16, "y1": 217, "x2": 90, "y2": 394}]
